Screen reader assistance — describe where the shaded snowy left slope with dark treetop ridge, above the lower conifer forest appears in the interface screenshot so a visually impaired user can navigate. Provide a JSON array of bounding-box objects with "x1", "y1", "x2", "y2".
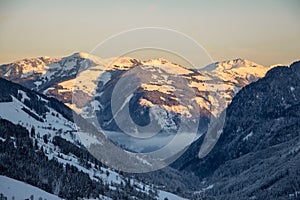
[{"x1": 0, "y1": 78, "x2": 164, "y2": 170}]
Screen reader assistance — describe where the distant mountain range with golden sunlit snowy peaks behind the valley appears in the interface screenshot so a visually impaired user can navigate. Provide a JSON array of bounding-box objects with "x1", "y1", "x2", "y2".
[{"x1": 0, "y1": 52, "x2": 270, "y2": 151}]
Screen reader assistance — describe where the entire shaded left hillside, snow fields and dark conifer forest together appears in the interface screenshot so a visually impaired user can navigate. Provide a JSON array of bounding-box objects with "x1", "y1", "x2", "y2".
[{"x1": 0, "y1": 78, "x2": 195, "y2": 199}]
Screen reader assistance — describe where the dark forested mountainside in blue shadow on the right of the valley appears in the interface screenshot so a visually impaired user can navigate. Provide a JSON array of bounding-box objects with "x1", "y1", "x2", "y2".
[{"x1": 173, "y1": 61, "x2": 300, "y2": 199}]
